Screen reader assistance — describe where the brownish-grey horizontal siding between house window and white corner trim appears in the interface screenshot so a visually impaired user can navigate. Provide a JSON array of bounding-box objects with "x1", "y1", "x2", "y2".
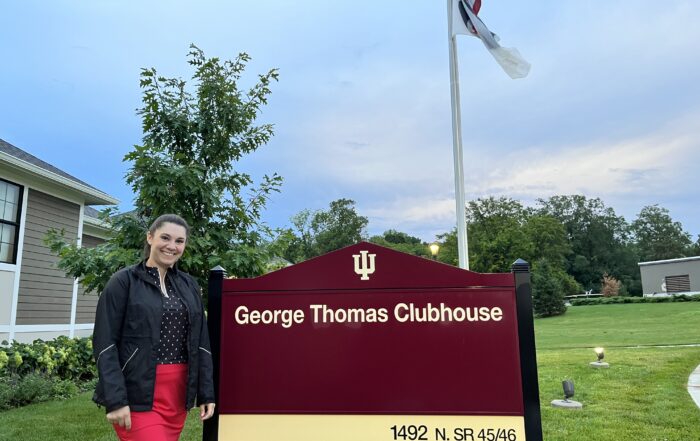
[{"x1": 17, "y1": 189, "x2": 80, "y2": 325}]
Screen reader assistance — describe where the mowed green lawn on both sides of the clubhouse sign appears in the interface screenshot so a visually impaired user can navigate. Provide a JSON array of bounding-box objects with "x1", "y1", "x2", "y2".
[{"x1": 0, "y1": 302, "x2": 700, "y2": 441}]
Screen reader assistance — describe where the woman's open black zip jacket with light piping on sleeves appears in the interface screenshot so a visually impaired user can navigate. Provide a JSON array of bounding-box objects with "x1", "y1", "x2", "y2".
[{"x1": 92, "y1": 262, "x2": 214, "y2": 412}]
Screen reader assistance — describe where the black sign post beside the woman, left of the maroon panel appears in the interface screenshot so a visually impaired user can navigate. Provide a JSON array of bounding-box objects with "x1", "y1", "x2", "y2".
[{"x1": 202, "y1": 265, "x2": 226, "y2": 441}]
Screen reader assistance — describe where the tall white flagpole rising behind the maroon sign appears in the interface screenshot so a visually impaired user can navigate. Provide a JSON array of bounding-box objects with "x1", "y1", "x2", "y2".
[{"x1": 447, "y1": 0, "x2": 469, "y2": 269}]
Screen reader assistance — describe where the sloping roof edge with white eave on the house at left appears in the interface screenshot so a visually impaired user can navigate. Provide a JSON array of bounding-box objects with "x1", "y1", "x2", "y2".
[{"x1": 0, "y1": 139, "x2": 119, "y2": 205}]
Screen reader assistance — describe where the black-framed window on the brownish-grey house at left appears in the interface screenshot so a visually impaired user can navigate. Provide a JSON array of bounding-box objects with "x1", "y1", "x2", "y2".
[{"x1": 0, "y1": 179, "x2": 22, "y2": 264}]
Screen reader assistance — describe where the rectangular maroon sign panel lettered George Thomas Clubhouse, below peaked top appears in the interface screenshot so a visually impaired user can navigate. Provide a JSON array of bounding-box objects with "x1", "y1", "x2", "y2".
[{"x1": 219, "y1": 289, "x2": 523, "y2": 415}]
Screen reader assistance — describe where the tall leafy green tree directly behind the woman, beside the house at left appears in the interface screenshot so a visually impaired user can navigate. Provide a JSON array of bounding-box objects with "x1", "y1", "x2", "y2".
[{"x1": 47, "y1": 45, "x2": 281, "y2": 292}]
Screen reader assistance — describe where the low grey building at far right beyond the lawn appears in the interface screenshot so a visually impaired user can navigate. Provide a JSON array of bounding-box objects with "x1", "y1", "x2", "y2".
[{"x1": 639, "y1": 256, "x2": 700, "y2": 296}]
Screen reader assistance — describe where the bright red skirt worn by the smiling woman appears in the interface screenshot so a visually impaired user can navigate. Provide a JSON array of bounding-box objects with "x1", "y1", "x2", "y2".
[{"x1": 114, "y1": 364, "x2": 187, "y2": 441}]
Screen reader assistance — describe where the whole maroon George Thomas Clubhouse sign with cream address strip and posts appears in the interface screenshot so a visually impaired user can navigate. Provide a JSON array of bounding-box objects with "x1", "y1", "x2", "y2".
[{"x1": 204, "y1": 242, "x2": 542, "y2": 441}]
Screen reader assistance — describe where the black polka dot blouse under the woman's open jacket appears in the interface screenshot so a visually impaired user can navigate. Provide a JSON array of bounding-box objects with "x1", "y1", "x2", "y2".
[{"x1": 146, "y1": 267, "x2": 188, "y2": 364}]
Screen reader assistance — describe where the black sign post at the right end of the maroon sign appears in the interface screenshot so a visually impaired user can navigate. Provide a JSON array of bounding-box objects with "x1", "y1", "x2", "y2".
[{"x1": 511, "y1": 259, "x2": 542, "y2": 441}]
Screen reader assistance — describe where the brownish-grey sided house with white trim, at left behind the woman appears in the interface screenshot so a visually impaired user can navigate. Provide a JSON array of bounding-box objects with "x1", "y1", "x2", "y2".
[{"x1": 0, "y1": 139, "x2": 119, "y2": 342}]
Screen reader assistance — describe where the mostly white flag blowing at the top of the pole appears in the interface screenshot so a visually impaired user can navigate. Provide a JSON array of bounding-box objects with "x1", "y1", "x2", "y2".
[{"x1": 451, "y1": 0, "x2": 530, "y2": 79}]
